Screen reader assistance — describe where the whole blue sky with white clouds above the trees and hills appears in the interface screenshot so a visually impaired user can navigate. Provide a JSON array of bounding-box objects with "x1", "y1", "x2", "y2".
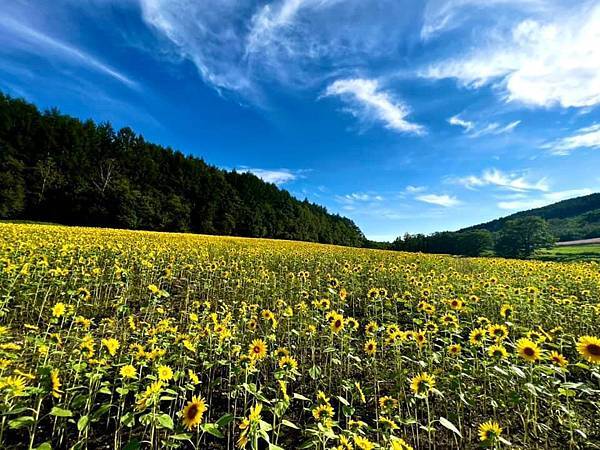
[{"x1": 0, "y1": 0, "x2": 600, "y2": 240}]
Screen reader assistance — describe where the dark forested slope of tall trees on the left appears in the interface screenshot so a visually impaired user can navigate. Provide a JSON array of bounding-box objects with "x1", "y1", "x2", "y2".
[{"x1": 0, "y1": 93, "x2": 366, "y2": 247}]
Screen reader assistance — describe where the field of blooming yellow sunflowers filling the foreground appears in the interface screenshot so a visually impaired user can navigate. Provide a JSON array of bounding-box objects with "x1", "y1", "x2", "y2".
[{"x1": 0, "y1": 224, "x2": 600, "y2": 450}]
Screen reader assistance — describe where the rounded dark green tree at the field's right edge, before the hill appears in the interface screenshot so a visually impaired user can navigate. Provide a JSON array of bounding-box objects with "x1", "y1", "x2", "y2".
[{"x1": 495, "y1": 216, "x2": 556, "y2": 258}]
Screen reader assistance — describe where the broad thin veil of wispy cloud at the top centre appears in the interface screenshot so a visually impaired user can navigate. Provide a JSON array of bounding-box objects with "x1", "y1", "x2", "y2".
[{"x1": 138, "y1": 0, "x2": 421, "y2": 97}]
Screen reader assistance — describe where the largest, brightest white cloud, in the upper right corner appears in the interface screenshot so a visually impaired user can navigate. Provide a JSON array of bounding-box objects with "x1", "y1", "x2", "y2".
[{"x1": 420, "y1": 1, "x2": 600, "y2": 108}]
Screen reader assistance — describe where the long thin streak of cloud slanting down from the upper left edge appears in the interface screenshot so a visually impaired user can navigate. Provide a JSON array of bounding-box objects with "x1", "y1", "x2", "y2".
[{"x1": 0, "y1": 15, "x2": 139, "y2": 89}]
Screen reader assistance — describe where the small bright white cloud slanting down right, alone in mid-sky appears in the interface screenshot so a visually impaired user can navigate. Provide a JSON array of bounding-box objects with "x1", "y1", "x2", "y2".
[{"x1": 323, "y1": 78, "x2": 425, "y2": 135}]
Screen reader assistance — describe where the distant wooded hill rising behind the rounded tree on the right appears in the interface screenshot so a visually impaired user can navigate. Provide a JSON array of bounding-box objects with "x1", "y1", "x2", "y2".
[{"x1": 459, "y1": 193, "x2": 600, "y2": 241}]
